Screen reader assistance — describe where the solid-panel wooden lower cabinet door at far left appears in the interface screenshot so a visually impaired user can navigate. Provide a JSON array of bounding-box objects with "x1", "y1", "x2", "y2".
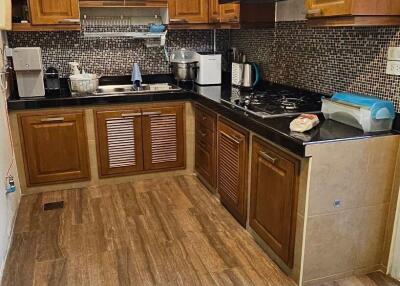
[{"x1": 19, "y1": 111, "x2": 90, "y2": 186}]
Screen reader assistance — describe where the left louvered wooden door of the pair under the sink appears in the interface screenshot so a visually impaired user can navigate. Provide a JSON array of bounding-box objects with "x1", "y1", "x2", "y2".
[{"x1": 96, "y1": 109, "x2": 143, "y2": 177}]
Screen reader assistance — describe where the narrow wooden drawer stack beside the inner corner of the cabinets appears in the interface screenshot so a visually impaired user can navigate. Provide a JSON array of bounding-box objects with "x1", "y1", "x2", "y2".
[{"x1": 195, "y1": 105, "x2": 217, "y2": 191}]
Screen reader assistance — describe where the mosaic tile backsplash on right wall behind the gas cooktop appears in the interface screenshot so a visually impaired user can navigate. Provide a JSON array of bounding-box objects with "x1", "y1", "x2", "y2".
[{"x1": 231, "y1": 21, "x2": 400, "y2": 112}]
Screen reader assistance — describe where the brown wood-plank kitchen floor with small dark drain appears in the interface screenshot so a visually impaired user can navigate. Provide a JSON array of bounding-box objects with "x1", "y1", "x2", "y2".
[{"x1": 2, "y1": 176, "x2": 398, "y2": 286}]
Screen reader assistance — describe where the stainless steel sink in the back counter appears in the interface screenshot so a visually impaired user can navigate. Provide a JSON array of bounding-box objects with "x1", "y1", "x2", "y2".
[{"x1": 93, "y1": 83, "x2": 181, "y2": 95}]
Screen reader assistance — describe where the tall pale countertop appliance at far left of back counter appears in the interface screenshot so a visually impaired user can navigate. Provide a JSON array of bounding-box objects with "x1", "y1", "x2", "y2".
[{"x1": 12, "y1": 48, "x2": 45, "y2": 97}]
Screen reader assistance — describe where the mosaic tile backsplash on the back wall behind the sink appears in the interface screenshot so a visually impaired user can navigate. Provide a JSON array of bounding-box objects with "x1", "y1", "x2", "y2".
[{"x1": 8, "y1": 26, "x2": 228, "y2": 76}]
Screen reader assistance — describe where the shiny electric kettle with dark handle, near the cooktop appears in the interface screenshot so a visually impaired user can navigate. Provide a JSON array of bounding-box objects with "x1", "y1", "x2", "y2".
[{"x1": 232, "y1": 62, "x2": 261, "y2": 88}]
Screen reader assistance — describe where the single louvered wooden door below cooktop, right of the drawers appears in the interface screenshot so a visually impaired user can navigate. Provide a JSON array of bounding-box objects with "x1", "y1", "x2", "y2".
[{"x1": 217, "y1": 120, "x2": 248, "y2": 226}]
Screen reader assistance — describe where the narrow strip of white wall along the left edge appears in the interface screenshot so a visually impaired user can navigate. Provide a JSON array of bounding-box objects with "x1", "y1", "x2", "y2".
[{"x1": 0, "y1": 31, "x2": 21, "y2": 277}]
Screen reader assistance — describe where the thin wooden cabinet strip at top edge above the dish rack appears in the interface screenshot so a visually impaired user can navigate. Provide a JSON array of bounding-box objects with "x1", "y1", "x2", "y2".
[{"x1": 79, "y1": 0, "x2": 168, "y2": 8}]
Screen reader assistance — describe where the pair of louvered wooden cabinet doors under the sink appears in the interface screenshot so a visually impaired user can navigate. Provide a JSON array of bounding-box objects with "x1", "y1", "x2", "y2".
[{"x1": 95, "y1": 104, "x2": 186, "y2": 177}]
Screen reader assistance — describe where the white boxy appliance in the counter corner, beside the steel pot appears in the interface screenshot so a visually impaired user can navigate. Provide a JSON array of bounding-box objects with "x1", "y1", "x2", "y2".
[{"x1": 195, "y1": 53, "x2": 222, "y2": 85}]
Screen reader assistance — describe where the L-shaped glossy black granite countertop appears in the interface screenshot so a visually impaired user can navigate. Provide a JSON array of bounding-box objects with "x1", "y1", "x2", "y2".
[{"x1": 8, "y1": 75, "x2": 397, "y2": 156}]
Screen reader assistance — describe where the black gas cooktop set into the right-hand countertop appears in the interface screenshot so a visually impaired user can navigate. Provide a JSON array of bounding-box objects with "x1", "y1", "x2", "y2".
[{"x1": 221, "y1": 84, "x2": 323, "y2": 118}]
